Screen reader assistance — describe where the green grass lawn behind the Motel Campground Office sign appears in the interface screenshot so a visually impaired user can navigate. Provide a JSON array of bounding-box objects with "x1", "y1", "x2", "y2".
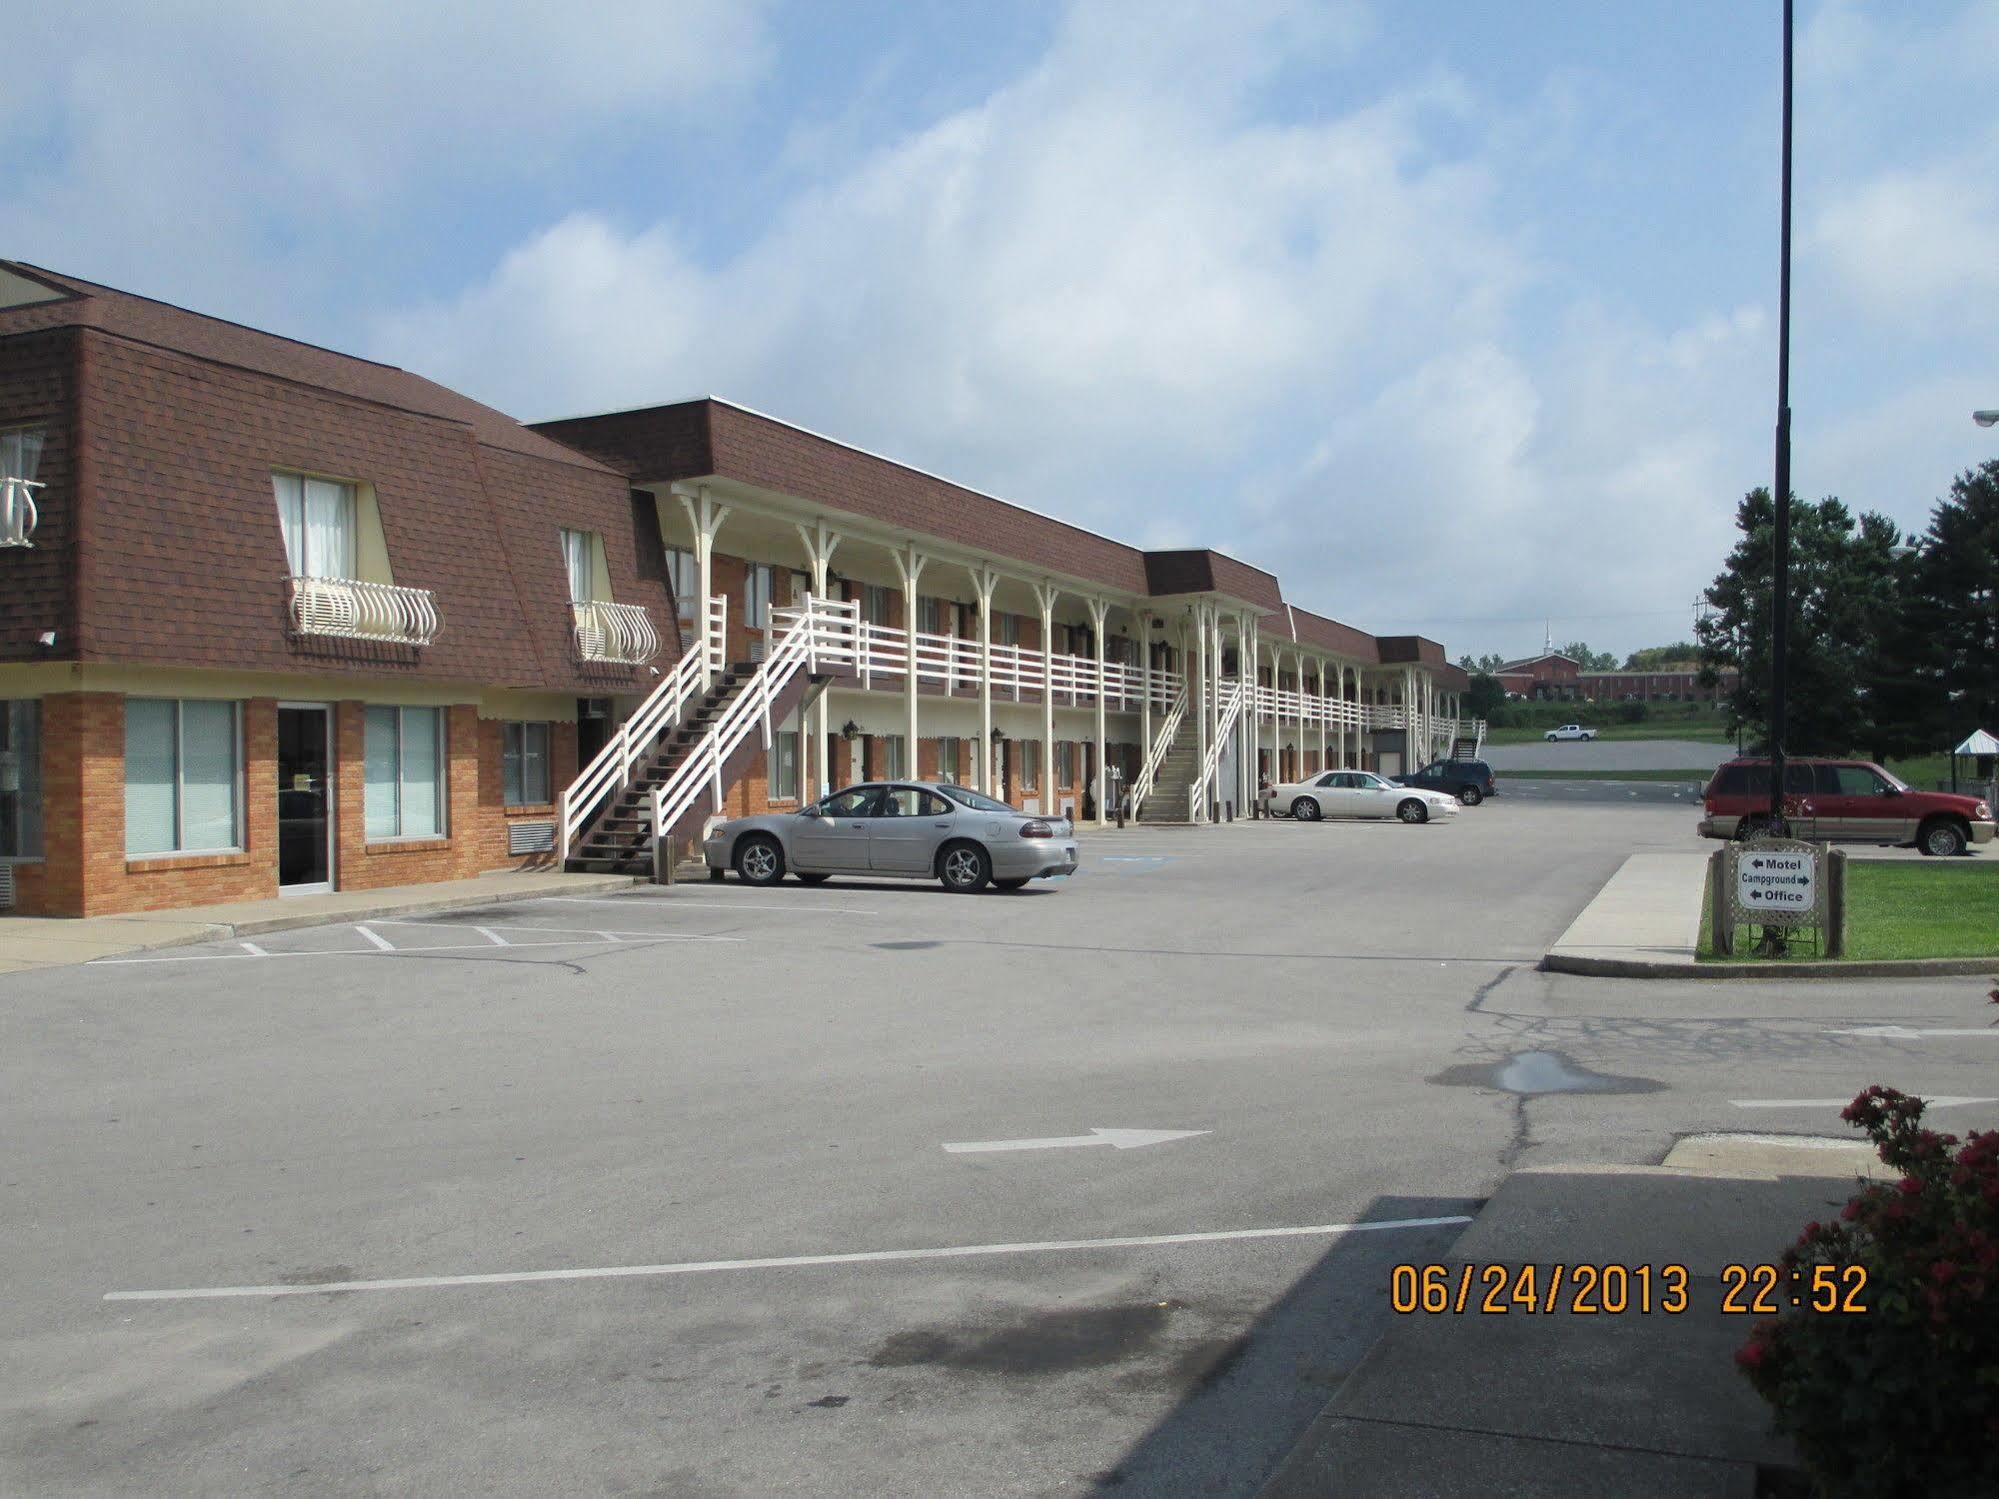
[{"x1": 1699, "y1": 855, "x2": 1999, "y2": 967}]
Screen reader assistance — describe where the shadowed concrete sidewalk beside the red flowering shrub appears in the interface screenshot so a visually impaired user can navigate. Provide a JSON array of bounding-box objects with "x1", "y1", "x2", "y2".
[{"x1": 1259, "y1": 1135, "x2": 1881, "y2": 1499}]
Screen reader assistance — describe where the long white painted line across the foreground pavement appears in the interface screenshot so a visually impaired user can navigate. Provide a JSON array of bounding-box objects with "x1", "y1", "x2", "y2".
[{"x1": 104, "y1": 1215, "x2": 1471, "y2": 1301}]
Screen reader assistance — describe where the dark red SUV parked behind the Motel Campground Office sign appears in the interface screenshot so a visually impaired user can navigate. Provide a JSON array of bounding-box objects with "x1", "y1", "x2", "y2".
[{"x1": 1701, "y1": 759, "x2": 1993, "y2": 855}]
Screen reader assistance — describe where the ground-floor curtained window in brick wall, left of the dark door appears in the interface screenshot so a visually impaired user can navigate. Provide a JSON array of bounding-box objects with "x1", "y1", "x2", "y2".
[{"x1": 126, "y1": 698, "x2": 242, "y2": 853}]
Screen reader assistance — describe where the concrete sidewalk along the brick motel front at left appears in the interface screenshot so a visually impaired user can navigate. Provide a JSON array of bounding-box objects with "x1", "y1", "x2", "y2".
[{"x1": 0, "y1": 869, "x2": 638, "y2": 973}]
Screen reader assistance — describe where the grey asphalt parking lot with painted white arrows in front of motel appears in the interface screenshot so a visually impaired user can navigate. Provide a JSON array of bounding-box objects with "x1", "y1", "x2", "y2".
[{"x1": 0, "y1": 793, "x2": 1999, "y2": 1495}]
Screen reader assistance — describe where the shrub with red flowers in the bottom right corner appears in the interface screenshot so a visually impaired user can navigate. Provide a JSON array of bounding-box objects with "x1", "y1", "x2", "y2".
[{"x1": 1735, "y1": 1087, "x2": 1999, "y2": 1499}]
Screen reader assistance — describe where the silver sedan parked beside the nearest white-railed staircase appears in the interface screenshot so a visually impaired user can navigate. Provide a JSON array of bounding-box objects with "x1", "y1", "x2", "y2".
[{"x1": 702, "y1": 781, "x2": 1075, "y2": 893}]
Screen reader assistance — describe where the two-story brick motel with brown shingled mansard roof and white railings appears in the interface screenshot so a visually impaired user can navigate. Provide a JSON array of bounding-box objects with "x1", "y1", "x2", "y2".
[{"x1": 0, "y1": 262, "x2": 1481, "y2": 915}]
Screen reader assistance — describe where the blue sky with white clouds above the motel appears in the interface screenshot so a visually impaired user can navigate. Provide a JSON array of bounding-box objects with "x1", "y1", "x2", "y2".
[{"x1": 0, "y1": 0, "x2": 1999, "y2": 654}]
